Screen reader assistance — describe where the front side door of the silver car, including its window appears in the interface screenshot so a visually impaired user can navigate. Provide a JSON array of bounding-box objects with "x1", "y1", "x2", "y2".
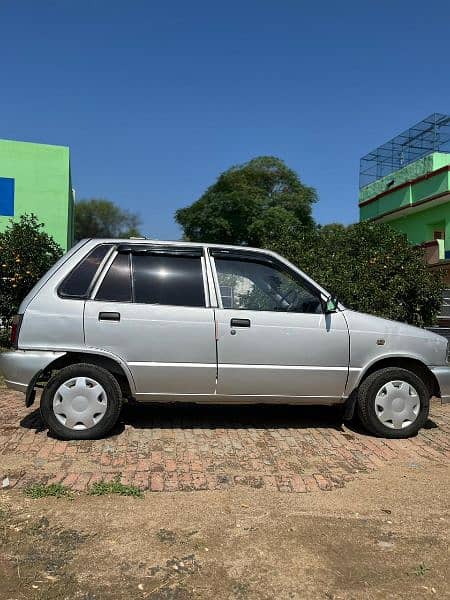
[{"x1": 211, "y1": 249, "x2": 349, "y2": 403}]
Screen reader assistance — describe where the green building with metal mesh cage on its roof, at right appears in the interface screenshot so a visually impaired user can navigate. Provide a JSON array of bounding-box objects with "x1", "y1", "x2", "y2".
[{"x1": 359, "y1": 113, "x2": 450, "y2": 263}]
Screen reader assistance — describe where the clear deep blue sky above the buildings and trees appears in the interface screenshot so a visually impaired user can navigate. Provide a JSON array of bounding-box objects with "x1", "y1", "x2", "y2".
[{"x1": 0, "y1": 0, "x2": 450, "y2": 239}]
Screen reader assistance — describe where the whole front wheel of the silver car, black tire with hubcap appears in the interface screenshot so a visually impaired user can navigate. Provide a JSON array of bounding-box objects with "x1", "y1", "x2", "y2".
[{"x1": 357, "y1": 367, "x2": 430, "y2": 438}]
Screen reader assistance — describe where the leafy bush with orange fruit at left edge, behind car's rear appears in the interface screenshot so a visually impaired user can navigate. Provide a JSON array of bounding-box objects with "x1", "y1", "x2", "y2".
[{"x1": 0, "y1": 215, "x2": 63, "y2": 338}]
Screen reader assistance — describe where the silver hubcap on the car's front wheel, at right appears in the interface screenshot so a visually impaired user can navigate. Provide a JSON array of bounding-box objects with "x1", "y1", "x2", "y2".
[{"x1": 375, "y1": 381, "x2": 420, "y2": 429}]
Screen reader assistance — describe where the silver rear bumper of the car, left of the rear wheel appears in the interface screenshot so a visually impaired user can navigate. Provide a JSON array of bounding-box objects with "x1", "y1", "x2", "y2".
[{"x1": 0, "y1": 350, "x2": 66, "y2": 394}]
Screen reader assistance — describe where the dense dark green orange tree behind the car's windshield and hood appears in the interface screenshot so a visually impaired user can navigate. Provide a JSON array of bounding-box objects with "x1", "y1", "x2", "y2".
[{"x1": 267, "y1": 222, "x2": 444, "y2": 327}]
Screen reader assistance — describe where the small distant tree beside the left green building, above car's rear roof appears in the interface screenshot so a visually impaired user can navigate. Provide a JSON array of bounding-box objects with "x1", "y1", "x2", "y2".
[{"x1": 75, "y1": 198, "x2": 141, "y2": 241}]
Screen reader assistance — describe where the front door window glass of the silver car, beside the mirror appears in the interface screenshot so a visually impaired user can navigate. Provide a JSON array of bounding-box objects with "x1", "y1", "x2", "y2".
[{"x1": 215, "y1": 258, "x2": 322, "y2": 313}]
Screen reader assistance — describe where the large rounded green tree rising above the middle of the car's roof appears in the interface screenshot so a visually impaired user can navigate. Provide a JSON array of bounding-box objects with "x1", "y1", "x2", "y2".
[{"x1": 175, "y1": 156, "x2": 317, "y2": 246}]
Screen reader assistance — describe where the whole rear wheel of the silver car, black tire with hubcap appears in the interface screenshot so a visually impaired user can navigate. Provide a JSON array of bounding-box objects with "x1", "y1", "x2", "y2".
[{"x1": 41, "y1": 363, "x2": 122, "y2": 440}]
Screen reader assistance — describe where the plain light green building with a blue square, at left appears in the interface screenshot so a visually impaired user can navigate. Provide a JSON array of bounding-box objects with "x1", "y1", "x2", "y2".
[{"x1": 0, "y1": 140, "x2": 74, "y2": 250}]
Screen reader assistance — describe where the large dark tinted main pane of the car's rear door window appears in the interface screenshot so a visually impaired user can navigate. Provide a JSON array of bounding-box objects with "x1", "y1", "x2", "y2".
[{"x1": 132, "y1": 254, "x2": 205, "y2": 306}]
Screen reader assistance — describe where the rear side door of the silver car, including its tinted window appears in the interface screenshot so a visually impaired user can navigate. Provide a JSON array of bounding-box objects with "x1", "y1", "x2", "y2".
[{"x1": 84, "y1": 245, "x2": 217, "y2": 400}]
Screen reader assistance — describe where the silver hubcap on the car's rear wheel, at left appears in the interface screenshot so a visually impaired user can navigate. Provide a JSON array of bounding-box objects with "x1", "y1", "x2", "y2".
[{"x1": 53, "y1": 377, "x2": 108, "y2": 430}]
